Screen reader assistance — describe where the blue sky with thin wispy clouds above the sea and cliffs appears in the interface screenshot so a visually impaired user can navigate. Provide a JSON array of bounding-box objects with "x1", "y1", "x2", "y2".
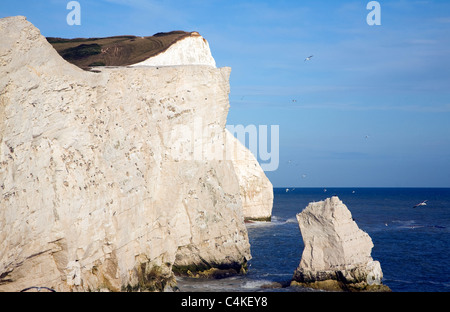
[{"x1": 0, "y1": 0, "x2": 450, "y2": 187}]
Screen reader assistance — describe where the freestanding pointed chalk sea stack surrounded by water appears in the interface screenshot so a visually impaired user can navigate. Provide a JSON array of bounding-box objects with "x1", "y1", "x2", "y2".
[{"x1": 292, "y1": 196, "x2": 390, "y2": 291}]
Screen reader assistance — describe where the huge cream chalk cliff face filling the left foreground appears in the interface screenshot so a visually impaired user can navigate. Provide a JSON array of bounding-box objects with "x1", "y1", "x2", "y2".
[{"x1": 0, "y1": 17, "x2": 251, "y2": 291}]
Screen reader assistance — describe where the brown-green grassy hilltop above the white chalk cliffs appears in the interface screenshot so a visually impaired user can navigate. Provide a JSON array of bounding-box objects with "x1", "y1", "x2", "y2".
[{"x1": 47, "y1": 31, "x2": 191, "y2": 69}]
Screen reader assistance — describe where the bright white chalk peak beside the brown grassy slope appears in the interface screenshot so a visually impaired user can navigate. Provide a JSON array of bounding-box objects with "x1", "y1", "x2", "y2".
[{"x1": 131, "y1": 32, "x2": 216, "y2": 67}]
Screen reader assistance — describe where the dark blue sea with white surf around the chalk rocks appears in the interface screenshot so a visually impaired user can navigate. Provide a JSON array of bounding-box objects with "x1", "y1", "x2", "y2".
[{"x1": 178, "y1": 188, "x2": 450, "y2": 292}]
